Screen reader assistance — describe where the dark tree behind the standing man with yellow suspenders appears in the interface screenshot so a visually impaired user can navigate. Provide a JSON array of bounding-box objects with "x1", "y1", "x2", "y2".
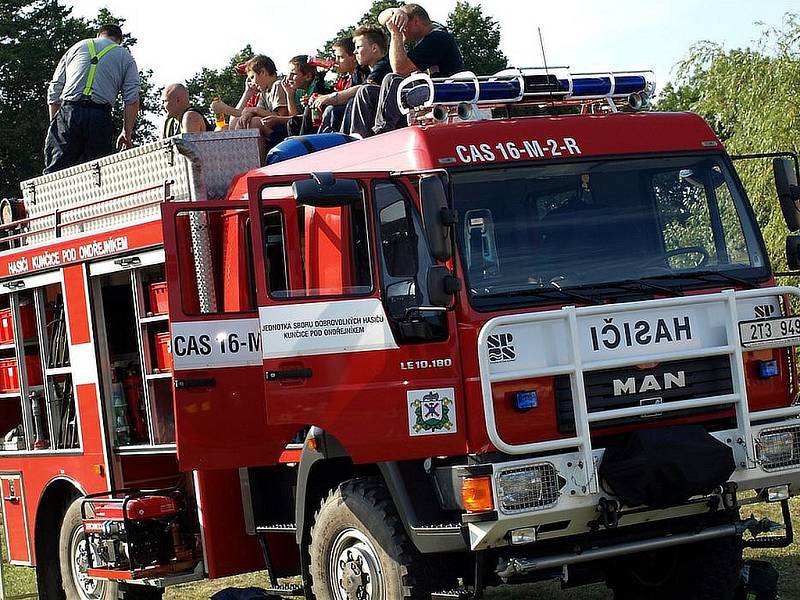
[{"x1": 0, "y1": 0, "x2": 159, "y2": 197}]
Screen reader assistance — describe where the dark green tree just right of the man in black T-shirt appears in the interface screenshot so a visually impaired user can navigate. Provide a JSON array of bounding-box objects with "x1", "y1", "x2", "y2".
[{"x1": 447, "y1": 0, "x2": 508, "y2": 75}]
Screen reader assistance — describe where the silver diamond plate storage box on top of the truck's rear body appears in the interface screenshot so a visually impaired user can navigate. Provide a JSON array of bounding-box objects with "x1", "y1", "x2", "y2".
[{"x1": 20, "y1": 130, "x2": 265, "y2": 246}]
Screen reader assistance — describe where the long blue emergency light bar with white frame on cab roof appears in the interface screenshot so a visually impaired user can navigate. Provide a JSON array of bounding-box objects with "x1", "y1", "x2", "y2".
[{"x1": 398, "y1": 67, "x2": 655, "y2": 113}]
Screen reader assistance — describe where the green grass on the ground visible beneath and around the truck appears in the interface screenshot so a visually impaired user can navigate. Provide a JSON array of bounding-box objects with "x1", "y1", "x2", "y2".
[{"x1": 3, "y1": 498, "x2": 800, "y2": 600}]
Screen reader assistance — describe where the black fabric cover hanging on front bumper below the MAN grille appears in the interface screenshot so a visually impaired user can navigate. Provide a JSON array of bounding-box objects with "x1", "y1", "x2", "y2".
[{"x1": 599, "y1": 425, "x2": 736, "y2": 508}]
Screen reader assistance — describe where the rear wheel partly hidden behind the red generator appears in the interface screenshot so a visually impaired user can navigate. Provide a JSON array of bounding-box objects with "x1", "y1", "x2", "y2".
[{"x1": 58, "y1": 498, "x2": 164, "y2": 600}]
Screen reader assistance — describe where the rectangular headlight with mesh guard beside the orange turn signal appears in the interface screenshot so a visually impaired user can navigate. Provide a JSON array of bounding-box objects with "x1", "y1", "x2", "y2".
[{"x1": 497, "y1": 463, "x2": 560, "y2": 513}]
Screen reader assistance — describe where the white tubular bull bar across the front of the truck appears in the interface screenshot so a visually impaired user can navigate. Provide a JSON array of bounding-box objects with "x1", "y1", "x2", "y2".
[{"x1": 478, "y1": 286, "x2": 800, "y2": 493}]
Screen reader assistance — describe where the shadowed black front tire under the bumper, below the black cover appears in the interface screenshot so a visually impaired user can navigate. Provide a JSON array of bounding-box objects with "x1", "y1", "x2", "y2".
[{"x1": 606, "y1": 537, "x2": 743, "y2": 600}]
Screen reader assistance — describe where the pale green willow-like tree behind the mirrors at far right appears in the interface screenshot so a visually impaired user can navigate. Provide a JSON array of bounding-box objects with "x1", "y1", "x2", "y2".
[{"x1": 657, "y1": 14, "x2": 800, "y2": 269}]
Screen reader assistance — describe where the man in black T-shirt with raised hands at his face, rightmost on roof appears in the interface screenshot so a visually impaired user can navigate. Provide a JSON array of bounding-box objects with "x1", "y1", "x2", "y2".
[{"x1": 352, "y1": 4, "x2": 464, "y2": 137}]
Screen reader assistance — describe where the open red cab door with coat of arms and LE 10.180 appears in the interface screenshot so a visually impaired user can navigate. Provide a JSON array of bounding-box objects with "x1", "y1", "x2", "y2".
[{"x1": 249, "y1": 175, "x2": 465, "y2": 462}]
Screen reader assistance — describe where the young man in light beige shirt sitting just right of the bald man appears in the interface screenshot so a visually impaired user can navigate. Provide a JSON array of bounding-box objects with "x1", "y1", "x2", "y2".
[{"x1": 211, "y1": 54, "x2": 289, "y2": 136}]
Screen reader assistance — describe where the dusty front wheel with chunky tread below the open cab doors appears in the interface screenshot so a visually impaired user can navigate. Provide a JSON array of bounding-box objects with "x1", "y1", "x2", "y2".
[{"x1": 309, "y1": 478, "x2": 431, "y2": 600}]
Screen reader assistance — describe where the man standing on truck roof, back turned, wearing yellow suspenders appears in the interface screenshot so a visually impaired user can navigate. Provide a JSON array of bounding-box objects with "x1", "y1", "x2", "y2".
[{"x1": 44, "y1": 25, "x2": 139, "y2": 173}]
